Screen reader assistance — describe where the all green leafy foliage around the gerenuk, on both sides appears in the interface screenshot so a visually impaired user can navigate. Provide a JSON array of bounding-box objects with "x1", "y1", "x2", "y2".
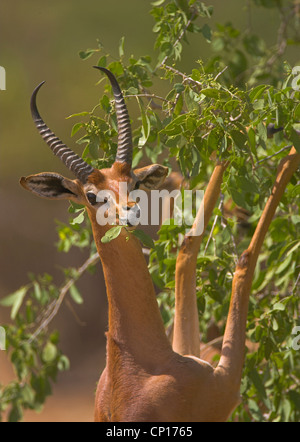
[{"x1": 0, "y1": 0, "x2": 300, "y2": 422}]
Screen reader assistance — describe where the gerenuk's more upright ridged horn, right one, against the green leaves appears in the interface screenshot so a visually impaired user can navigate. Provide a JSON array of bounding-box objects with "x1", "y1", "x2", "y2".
[{"x1": 94, "y1": 66, "x2": 133, "y2": 166}]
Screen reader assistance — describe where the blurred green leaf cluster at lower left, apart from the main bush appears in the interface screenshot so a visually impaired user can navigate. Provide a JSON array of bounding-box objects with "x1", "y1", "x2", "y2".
[{"x1": 0, "y1": 274, "x2": 69, "y2": 422}]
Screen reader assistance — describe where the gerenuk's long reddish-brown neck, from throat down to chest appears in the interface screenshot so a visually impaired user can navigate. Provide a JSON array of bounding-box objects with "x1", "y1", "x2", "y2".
[{"x1": 89, "y1": 209, "x2": 172, "y2": 365}]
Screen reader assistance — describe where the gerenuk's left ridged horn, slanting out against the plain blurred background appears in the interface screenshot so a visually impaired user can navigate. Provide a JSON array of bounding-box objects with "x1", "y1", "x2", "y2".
[{"x1": 30, "y1": 81, "x2": 94, "y2": 184}]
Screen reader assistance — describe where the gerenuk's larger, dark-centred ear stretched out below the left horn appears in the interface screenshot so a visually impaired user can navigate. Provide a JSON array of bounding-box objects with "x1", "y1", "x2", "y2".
[{"x1": 20, "y1": 172, "x2": 82, "y2": 202}]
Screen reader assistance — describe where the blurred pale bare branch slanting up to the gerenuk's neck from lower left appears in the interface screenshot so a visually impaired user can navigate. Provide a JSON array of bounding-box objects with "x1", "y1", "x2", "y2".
[{"x1": 28, "y1": 253, "x2": 99, "y2": 344}]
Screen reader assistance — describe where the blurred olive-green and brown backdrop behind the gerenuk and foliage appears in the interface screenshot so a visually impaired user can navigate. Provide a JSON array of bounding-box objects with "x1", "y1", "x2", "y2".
[{"x1": 0, "y1": 0, "x2": 297, "y2": 420}]
